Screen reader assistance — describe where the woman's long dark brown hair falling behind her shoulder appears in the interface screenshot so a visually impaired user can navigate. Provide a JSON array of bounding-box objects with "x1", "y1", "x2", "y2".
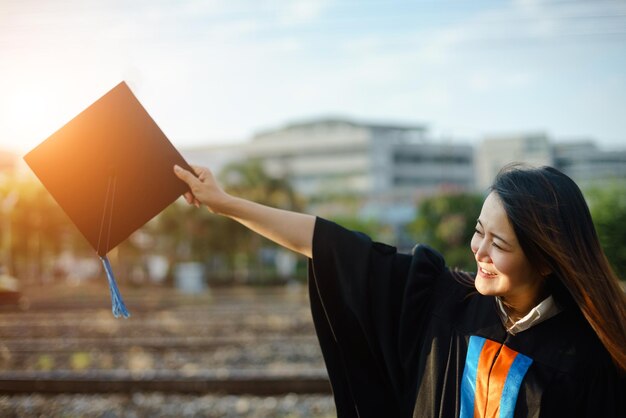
[{"x1": 490, "y1": 164, "x2": 626, "y2": 371}]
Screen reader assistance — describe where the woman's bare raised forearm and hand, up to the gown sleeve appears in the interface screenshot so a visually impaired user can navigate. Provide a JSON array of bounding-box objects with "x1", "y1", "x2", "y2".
[{"x1": 174, "y1": 166, "x2": 315, "y2": 258}]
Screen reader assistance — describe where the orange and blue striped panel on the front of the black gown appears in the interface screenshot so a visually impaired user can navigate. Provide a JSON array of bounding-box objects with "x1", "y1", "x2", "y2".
[{"x1": 460, "y1": 335, "x2": 533, "y2": 418}]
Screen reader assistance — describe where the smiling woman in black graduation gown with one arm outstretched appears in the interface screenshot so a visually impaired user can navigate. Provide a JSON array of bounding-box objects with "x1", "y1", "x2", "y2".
[{"x1": 175, "y1": 163, "x2": 626, "y2": 418}]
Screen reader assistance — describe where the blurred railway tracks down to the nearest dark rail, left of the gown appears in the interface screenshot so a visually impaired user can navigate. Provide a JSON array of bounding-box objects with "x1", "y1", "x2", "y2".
[{"x1": 0, "y1": 291, "x2": 331, "y2": 397}]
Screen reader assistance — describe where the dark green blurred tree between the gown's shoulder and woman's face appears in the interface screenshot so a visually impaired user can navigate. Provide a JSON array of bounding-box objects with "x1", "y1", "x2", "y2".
[{"x1": 408, "y1": 193, "x2": 484, "y2": 271}]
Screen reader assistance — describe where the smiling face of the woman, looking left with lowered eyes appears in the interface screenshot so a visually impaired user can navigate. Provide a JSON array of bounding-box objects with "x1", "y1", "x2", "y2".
[{"x1": 470, "y1": 192, "x2": 543, "y2": 309}]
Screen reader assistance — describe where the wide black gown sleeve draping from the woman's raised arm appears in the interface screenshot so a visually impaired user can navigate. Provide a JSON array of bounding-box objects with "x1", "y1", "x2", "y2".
[{"x1": 309, "y1": 218, "x2": 444, "y2": 418}]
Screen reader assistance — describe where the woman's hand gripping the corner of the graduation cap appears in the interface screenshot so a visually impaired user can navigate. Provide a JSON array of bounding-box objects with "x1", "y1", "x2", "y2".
[{"x1": 174, "y1": 165, "x2": 231, "y2": 214}]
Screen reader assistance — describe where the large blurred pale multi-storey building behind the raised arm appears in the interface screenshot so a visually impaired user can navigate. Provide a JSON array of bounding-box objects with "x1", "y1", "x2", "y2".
[{"x1": 183, "y1": 119, "x2": 474, "y2": 229}]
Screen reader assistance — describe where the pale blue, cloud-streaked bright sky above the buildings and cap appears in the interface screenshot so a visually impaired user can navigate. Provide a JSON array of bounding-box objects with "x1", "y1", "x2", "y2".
[{"x1": 0, "y1": 0, "x2": 626, "y2": 153}]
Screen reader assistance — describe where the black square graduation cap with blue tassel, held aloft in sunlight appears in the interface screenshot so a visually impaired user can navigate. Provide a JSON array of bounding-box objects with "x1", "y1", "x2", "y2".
[{"x1": 24, "y1": 82, "x2": 193, "y2": 317}]
